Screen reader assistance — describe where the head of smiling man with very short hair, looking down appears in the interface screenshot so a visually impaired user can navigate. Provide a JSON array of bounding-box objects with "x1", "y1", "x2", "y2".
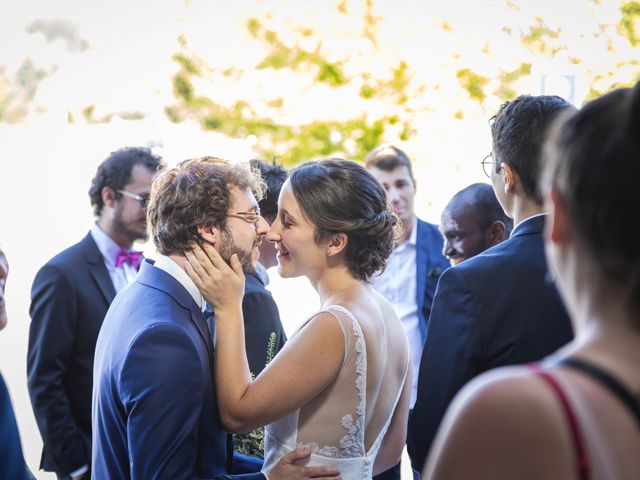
[{"x1": 440, "y1": 183, "x2": 513, "y2": 265}]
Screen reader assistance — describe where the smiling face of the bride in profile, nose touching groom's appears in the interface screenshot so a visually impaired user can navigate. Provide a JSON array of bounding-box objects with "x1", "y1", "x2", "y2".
[{"x1": 267, "y1": 180, "x2": 326, "y2": 278}]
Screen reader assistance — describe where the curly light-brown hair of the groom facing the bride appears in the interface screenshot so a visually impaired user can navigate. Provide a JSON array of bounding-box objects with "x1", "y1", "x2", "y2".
[{"x1": 147, "y1": 157, "x2": 265, "y2": 255}]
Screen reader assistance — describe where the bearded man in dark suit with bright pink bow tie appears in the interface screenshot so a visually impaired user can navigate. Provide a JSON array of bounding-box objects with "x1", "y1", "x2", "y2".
[{"x1": 27, "y1": 148, "x2": 162, "y2": 479}]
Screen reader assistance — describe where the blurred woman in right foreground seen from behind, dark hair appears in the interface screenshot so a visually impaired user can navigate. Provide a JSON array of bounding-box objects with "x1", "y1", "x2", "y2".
[{"x1": 424, "y1": 84, "x2": 640, "y2": 480}]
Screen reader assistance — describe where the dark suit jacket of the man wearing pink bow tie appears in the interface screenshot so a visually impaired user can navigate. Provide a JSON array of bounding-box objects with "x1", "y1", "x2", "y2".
[{"x1": 27, "y1": 234, "x2": 115, "y2": 474}]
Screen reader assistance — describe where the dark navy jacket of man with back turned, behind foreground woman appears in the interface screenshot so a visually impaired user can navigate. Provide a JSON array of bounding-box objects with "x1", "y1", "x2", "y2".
[{"x1": 407, "y1": 216, "x2": 573, "y2": 471}]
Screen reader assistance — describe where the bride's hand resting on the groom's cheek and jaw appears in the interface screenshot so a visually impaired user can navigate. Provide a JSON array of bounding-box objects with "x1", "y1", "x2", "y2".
[{"x1": 185, "y1": 243, "x2": 244, "y2": 311}]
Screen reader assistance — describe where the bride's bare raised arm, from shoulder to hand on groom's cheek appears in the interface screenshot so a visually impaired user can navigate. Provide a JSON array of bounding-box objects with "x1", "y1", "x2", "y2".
[{"x1": 186, "y1": 245, "x2": 345, "y2": 432}]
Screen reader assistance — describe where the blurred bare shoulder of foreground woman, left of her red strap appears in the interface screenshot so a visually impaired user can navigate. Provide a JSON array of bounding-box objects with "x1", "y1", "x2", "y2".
[{"x1": 430, "y1": 367, "x2": 572, "y2": 478}]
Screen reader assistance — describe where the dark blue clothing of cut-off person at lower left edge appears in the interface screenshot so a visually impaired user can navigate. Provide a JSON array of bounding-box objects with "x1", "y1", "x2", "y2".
[{"x1": 0, "y1": 375, "x2": 33, "y2": 480}]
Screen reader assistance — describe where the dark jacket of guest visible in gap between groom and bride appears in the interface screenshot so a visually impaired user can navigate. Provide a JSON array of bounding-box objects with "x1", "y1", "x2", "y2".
[{"x1": 242, "y1": 274, "x2": 287, "y2": 377}]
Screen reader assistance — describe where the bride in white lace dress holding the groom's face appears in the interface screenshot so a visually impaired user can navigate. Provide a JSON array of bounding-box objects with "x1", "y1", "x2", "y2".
[{"x1": 187, "y1": 159, "x2": 411, "y2": 479}]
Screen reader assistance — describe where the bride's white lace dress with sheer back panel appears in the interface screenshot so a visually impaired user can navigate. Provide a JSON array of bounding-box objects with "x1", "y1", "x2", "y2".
[{"x1": 263, "y1": 305, "x2": 409, "y2": 480}]
